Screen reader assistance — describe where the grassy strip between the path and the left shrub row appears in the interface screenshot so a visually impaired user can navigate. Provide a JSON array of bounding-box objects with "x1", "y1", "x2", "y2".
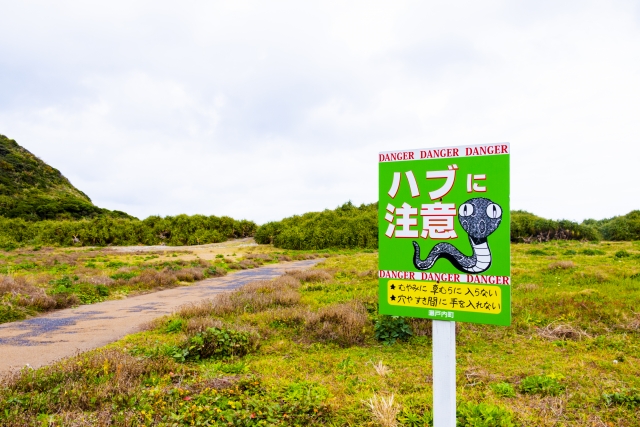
[{"x1": 0, "y1": 242, "x2": 340, "y2": 323}]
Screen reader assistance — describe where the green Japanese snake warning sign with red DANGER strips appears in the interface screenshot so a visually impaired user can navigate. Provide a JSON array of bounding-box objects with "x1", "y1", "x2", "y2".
[{"x1": 378, "y1": 143, "x2": 511, "y2": 325}]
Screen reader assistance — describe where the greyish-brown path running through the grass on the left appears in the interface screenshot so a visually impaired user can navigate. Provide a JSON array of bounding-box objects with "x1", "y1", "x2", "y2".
[{"x1": 0, "y1": 259, "x2": 322, "y2": 373}]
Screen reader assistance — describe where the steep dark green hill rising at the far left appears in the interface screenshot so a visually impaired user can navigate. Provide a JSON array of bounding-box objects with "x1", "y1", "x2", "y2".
[{"x1": 0, "y1": 135, "x2": 132, "y2": 221}]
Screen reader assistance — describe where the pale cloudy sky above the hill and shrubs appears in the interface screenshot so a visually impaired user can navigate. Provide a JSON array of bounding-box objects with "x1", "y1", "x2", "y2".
[{"x1": 0, "y1": 0, "x2": 640, "y2": 224}]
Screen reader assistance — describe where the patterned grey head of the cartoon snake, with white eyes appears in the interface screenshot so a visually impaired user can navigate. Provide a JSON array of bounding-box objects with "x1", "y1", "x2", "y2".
[{"x1": 458, "y1": 197, "x2": 502, "y2": 241}]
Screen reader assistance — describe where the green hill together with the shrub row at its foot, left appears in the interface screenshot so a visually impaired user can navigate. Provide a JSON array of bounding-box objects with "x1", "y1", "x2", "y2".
[{"x1": 0, "y1": 135, "x2": 257, "y2": 249}]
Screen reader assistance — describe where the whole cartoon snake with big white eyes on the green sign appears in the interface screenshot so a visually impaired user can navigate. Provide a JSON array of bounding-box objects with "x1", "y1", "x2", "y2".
[{"x1": 413, "y1": 197, "x2": 502, "y2": 274}]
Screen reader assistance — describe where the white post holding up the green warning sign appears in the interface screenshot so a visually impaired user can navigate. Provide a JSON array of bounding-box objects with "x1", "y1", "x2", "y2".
[{"x1": 433, "y1": 320, "x2": 456, "y2": 427}]
